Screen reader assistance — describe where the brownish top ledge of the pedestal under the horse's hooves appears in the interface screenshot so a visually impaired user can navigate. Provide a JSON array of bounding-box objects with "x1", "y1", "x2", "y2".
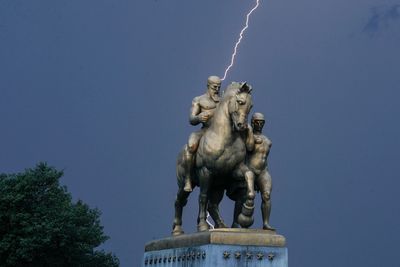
[{"x1": 145, "y1": 228, "x2": 286, "y2": 251}]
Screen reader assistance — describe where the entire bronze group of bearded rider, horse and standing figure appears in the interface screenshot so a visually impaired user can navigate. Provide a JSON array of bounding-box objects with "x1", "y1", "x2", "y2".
[{"x1": 172, "y1": 76, "x2": 274, "y2": 236}]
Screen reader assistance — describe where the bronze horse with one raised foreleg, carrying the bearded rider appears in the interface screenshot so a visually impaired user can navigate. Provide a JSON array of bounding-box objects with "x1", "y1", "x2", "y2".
[{"x1": 172, "y1": 82, "x2": 255, "y2": 235}]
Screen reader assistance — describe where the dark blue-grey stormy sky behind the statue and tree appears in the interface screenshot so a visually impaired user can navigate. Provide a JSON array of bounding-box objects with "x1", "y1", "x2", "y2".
[{"x1": 0, "y1": 0, "x2": 400, "y2": 267}]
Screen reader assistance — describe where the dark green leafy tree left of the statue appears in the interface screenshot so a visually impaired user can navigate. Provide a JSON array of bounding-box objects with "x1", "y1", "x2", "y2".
[{"x1": 0, "y1": 163, "x2": 119, "y2": 267}]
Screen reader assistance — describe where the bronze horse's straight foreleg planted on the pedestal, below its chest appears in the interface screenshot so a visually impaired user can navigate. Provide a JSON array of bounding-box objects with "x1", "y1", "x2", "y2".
[{"x1": 197, "y1": 167, "x2": 211, "y2": 232}]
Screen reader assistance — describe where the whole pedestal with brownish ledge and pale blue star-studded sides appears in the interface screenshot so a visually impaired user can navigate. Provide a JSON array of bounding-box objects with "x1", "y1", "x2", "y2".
[{"x1": 142, "y1": 229, "x2": 288, "y2": 267}]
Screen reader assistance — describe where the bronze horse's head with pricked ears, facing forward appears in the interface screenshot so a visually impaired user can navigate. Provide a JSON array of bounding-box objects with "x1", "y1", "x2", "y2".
[{"x1": 228, "y1": 82, "x2": 253, "y2": 131}]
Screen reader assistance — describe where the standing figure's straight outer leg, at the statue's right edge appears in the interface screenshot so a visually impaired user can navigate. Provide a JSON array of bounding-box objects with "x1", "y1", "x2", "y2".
[{"x1": 256, "y1": 170, "x2": 275, "y2": 230}]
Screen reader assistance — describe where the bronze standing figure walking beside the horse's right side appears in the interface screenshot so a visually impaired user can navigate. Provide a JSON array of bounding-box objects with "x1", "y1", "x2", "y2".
[{"x1": 247, "y1": 113, "x2": 274, "y2": 230}]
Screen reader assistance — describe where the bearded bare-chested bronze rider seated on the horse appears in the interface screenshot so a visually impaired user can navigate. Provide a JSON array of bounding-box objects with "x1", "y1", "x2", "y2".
[{"x1": 183, "y1": 76, "x2": 221, "y2": 192}]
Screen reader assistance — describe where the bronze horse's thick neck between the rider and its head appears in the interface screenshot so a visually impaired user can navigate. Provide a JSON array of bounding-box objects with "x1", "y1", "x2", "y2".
[{"x1": 210, "y1": 102, "x2": 232, "y2": 142}]
